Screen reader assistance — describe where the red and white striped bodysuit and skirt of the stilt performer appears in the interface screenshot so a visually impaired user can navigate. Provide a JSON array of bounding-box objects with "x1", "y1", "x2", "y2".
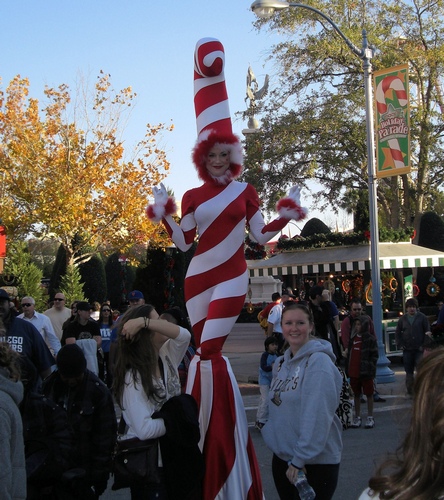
[{"x1": 163, "y1": 180, "x2": 288, "y2": 500}]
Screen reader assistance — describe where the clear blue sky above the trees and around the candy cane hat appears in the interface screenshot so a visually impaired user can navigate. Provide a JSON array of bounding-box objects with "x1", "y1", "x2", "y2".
[{"x1": 0, "y1": 0, "x2": 350, "y2": 233}]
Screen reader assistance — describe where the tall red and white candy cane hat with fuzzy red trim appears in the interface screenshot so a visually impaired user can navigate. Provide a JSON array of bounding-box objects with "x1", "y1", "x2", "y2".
[{"x1": 192, "y1": 38, "x2": 243, "y2": 182}]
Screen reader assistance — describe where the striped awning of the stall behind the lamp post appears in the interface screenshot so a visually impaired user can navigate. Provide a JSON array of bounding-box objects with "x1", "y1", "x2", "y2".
[{"x1": 248, "y1": 243, "x2": 444, "y2": 278}]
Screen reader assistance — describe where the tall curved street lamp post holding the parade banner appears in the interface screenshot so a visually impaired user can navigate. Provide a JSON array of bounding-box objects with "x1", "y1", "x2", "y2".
[{"x1": 251, "y1": 0, "x2": 395, "y2": 383}]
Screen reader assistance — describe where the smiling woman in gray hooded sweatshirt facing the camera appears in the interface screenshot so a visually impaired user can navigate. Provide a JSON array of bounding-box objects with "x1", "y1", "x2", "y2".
[{"x1": 262, "y1": 304, "x2": 342, "y2": 500}]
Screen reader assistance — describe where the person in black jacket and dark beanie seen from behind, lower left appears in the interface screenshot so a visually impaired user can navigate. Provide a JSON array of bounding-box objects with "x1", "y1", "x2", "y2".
[{"x1": 43, "y1": 344, "x2": 117, "y2": 500}]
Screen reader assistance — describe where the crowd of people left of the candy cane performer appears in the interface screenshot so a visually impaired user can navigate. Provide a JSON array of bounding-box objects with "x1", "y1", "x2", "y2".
[{"x1": 0, "y1": 289, "x2": 199, "y2": 500}]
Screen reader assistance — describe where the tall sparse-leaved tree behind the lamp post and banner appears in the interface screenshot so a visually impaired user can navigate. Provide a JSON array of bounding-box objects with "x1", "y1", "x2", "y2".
[{"x1": 244, "y1": 0, "x2": 444, "y2": 227}]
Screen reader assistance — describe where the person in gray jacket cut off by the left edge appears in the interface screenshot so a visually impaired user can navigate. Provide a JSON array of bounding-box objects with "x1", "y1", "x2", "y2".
[{"x1": 0, "y1": 342, "x2": 26, "y2": 500}]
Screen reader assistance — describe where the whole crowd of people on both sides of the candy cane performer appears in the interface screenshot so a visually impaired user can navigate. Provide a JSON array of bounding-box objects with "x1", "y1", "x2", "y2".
[{"x1": 0, "y1": 280, "x2": 444, "y2": 500}]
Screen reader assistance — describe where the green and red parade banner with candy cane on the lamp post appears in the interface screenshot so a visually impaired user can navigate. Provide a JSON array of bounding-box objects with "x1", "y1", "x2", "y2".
[{"x1": 373, "y1": 64, "x2": 410, "y2": 177}]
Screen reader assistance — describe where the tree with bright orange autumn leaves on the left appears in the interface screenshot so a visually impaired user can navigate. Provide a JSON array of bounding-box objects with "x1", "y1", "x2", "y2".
[{"x1": 0, "y1": 72, "x2": 172, "y2": 265}]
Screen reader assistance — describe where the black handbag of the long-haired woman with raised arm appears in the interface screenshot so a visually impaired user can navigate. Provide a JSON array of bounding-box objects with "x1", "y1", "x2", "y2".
[{"x1": 112, "y1": 417, "x2": 160, "y2": 491}]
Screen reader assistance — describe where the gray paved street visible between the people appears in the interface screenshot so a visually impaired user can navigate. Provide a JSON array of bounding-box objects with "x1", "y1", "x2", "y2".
[{"x1": 102, "y1": 324, "x2": 411, "y2": 500}]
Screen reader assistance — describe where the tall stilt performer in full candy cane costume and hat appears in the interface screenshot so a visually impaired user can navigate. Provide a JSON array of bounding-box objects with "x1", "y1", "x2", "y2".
[{"x1": 147, "y1": 38, "x2": 306, "y2": 499}]
